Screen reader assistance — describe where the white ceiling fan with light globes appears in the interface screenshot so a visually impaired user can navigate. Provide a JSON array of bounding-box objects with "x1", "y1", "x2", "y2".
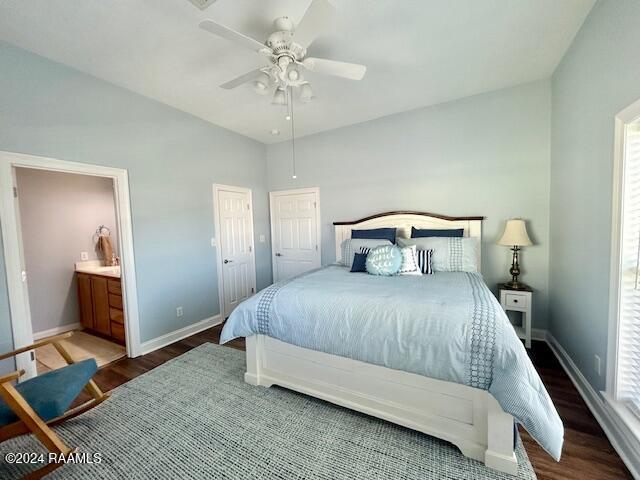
[{"x1": 200, "y1": 0, "x2": 367, "y2": 105}]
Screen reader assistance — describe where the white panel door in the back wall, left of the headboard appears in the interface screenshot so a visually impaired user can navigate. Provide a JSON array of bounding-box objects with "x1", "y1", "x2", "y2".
[{"x1": 271, "y1": 189, "x2": 320, "y2": 282}]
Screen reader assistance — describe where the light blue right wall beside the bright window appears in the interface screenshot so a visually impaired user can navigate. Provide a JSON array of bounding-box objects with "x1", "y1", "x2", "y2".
[{"x1": 549, "y1": 0, "x2": 640, "y2": 389}]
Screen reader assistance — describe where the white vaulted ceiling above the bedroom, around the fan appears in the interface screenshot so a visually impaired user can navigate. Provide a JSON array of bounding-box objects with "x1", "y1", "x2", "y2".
[{"x1": 0, "y1": 0, "x2": 595, "y2": 143}]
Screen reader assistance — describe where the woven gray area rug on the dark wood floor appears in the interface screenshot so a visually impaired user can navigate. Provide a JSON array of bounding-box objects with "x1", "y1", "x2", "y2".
[{"x1": 0, "y1": 344, "x2": 536, "y2": 480}]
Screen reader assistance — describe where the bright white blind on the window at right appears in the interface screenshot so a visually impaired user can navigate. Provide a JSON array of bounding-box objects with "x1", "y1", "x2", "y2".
[{"x1": 616, "y1": 121, "x2": 640, "y2": 416}]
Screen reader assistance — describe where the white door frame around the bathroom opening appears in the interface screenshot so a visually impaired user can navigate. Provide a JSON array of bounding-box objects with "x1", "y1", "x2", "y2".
[{"x1": 0, "y1": 151, "x2": 141, "y2": 378}]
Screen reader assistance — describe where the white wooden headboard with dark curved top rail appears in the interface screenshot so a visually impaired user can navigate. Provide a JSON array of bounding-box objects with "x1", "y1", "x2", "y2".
[{"x1": 333, "y1": 211, "x2": 484, "y2": 271}]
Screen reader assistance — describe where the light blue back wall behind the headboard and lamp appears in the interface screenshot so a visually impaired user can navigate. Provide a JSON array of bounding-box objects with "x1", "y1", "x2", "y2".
[{"x1": 267, "y1": 81, "x2": 550, "y2": 328}]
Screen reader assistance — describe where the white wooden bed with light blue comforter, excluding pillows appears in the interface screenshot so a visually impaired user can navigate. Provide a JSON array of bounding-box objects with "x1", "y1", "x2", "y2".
[{"x1": 221, "y1": 212, "x2": 563, "y2": 474}]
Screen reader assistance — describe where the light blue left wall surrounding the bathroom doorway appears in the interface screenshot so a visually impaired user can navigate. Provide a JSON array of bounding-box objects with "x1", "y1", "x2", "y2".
[{"x1": 0, "y1": 43, "x2": 271, "y2": 350}]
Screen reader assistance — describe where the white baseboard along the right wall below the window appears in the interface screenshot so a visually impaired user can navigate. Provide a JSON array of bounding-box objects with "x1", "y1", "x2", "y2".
[{"x1": 545, "y1": 331, "x2": 640, "y2": 479}]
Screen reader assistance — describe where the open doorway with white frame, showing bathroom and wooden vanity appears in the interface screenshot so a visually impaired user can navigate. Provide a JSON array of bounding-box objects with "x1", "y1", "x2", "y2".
[{"x1": 0, "y1": 152, "x2": 140, "y2": 378}]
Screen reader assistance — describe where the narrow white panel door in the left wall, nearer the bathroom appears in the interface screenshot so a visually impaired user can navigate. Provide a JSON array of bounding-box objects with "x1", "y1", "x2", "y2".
[{"x1": 216, "y1": 187, "x2": 255, "y2": 318}]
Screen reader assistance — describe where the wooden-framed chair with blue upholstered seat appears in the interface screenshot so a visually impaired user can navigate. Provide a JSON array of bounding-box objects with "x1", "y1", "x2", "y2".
[{"x1": 0, "y1": 332, "x2": 109, "y2": 478}]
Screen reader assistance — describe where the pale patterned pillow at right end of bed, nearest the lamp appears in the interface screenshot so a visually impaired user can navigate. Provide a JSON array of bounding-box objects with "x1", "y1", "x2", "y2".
[{"x1": 396, "y1": 237, "x2": 479, "y2": 272}]
